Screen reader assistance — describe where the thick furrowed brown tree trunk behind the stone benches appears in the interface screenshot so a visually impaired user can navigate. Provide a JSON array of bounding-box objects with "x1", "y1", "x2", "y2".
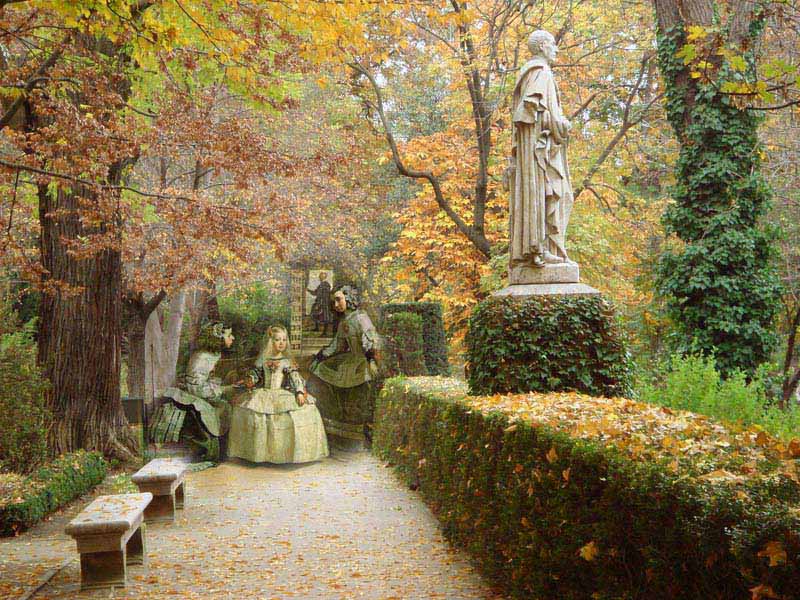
[{"x1": 38, "y1": 185, "x2": 134, "y2": 458}]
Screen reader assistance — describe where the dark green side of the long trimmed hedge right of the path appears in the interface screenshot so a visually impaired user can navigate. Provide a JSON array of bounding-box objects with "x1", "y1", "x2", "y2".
[{"x1": 373, "y1": 378, "x2": 800, "y2": 600}]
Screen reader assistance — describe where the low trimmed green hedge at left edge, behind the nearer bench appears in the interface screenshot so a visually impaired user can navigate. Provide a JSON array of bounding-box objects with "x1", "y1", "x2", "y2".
[{"x1": 0, "y1": 450, "x2": 108, "y2": 536}]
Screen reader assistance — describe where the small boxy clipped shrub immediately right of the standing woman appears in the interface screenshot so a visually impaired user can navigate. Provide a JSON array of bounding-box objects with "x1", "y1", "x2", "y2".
[{"x1": 381, "y1": 312, "x2": 427, "y2": 377}]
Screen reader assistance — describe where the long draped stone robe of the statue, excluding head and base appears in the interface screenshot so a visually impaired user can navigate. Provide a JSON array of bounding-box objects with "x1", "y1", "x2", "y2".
[{"x1": 509, "y1": 57, "x2": 573, "y2": 264}]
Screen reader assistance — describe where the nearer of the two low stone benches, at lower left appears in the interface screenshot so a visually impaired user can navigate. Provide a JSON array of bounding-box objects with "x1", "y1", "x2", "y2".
[{"x1": 66, "y1": 493, "x2": 153, "y2": 590}]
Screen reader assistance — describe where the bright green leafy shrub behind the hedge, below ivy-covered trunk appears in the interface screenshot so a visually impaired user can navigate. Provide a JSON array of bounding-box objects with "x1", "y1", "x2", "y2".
[{"x1": 640, "y1": 355, "x2": 800, "y2": 440}]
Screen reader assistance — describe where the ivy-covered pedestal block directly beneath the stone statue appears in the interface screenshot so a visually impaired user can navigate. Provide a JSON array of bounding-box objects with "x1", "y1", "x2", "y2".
[{"x1": 467, "y1": 295, "x2": 630, "y2": 396}]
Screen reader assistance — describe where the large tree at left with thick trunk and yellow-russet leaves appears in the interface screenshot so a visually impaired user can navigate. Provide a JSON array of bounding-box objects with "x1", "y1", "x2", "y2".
[{"x1": 0, "y1": 0, "x2": 302, "y2": 456}]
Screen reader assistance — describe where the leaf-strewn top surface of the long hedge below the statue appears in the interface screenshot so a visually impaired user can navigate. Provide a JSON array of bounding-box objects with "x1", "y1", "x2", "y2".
[{"x1": 394, "y1": 377, "x2": 800, "y2": 499}]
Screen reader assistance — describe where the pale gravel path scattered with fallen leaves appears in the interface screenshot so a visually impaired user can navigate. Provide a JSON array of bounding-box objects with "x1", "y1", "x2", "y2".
[{"x1": 0, "y1": 453, "x2": 499, "y2": 600}]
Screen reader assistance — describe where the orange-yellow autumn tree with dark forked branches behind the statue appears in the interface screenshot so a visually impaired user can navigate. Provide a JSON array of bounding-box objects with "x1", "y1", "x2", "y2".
[{"x1": 351, "y1": 0, "x2": 660, "y2": 340}]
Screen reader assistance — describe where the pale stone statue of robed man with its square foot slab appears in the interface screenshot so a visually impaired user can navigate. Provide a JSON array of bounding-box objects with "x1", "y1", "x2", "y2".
[{"x1": 505, "y1": 30, "x2": 579, "y2": 285}]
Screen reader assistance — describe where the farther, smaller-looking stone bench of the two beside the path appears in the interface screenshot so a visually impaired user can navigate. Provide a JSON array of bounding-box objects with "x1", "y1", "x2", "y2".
[{"x1": 131, "y1": 458, "x2": 187, "y2": 523}]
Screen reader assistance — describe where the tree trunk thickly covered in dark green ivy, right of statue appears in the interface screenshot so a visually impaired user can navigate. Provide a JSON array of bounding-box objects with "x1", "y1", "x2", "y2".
[{"x1": 654, "y1": 0, "x2": 780, "y2": 374}]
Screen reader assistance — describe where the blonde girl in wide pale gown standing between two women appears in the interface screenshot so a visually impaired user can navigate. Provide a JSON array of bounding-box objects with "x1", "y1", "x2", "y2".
[{"x1": 228, "y1": 326, "x2": 328, "y2": 463}]
